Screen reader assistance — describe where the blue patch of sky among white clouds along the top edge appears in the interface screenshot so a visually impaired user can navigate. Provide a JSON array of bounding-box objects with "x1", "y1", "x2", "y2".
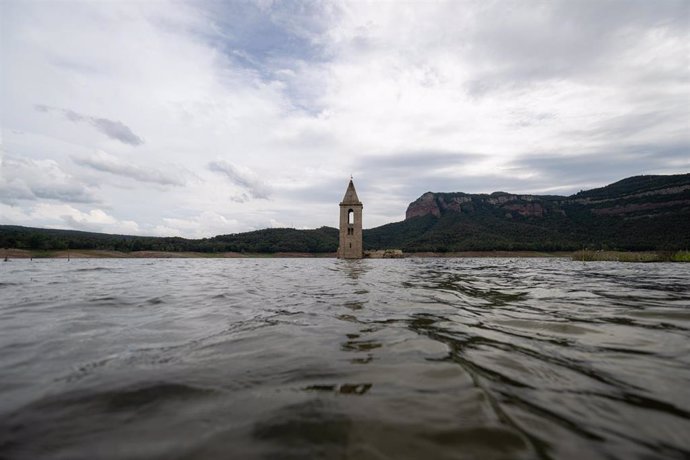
[{"x1": 196, "y1": 0, "x2": 340, "y2": 115}]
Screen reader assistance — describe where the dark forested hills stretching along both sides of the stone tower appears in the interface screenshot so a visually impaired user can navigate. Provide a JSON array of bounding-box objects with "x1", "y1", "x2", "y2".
[{"x1": 0, "y1": 174, "x2": 690, "y2": 253}]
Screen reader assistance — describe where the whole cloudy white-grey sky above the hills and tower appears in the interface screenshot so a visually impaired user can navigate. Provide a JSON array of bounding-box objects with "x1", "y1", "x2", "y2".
[{"x1": 0, "y1": 0, "x2": 690, "y2": 238}]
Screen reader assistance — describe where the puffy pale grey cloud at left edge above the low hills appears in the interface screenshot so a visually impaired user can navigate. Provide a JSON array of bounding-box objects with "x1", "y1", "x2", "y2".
[{"x1": 0, "y1": 157, "x2": 98, "y2": 204}]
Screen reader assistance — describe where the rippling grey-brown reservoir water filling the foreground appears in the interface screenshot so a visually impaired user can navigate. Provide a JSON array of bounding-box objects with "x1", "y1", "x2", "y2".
[{"x1": 0, "y1": 259, "x2": 690, "y2": 460}]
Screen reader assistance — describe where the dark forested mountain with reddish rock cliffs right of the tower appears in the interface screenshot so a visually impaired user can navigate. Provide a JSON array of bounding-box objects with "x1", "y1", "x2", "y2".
[{"x1": 364, "y1": 174, "x2": 690, "y2": 252}]
